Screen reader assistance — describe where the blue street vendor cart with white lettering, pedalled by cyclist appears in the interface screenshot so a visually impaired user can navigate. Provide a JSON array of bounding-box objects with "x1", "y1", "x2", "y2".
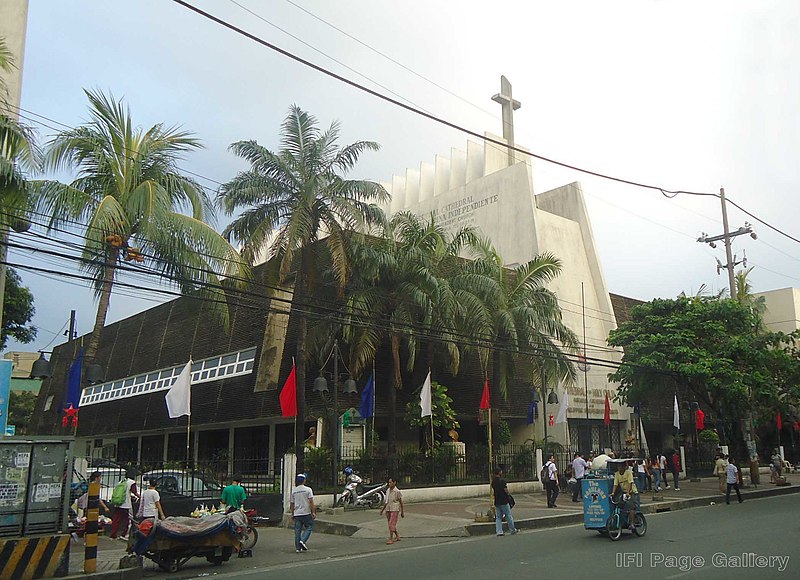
[{"x1": 581, "y1": 457, "x2": 647, "y2": 540}]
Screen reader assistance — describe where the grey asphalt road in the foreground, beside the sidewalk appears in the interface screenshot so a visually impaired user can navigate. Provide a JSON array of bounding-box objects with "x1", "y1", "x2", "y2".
[{"x1": 192, "y1": 494, "x2": 800, "y2": 580}]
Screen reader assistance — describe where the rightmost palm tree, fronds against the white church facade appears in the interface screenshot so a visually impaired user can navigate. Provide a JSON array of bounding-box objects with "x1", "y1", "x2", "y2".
[{"x1": 454, "y1": 239, "x2": 578, "y2": 397}]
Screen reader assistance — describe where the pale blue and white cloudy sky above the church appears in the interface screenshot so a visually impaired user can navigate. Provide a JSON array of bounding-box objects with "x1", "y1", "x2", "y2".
[{"x1": 8, "y1": 0, "x2": 800, "y2": 350}]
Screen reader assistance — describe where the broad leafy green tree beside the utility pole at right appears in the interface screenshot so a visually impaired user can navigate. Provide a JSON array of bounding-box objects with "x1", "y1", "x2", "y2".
[{"x1": 608, "y1": 296, "x2": 800, "y2": 453}]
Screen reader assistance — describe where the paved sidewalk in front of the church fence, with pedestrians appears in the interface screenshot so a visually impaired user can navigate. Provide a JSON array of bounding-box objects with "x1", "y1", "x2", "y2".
[{"x1": 314, "y1": 478, "x2": 800, "y2": 538}]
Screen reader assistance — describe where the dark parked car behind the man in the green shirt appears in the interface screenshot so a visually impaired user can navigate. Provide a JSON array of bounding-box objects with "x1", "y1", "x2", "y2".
[{"x1": 142, "y1": 469, "x2": 222, "y2": 516}]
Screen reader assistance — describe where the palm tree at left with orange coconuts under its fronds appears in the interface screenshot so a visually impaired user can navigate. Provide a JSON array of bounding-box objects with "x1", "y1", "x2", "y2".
[{"x1": 38, "y1": 91, "x2": 248, "y2": 362}]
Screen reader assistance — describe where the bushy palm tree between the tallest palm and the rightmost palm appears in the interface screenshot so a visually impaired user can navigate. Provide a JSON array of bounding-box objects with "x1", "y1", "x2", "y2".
[{"x1": 344, "y1": 212, "x2": 476, "y2": 457}]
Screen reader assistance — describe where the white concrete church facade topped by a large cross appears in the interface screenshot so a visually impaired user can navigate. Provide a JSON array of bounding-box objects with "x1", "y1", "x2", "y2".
[{"x1": 376, "y1": 77, "x2": 631, "y2": 449}]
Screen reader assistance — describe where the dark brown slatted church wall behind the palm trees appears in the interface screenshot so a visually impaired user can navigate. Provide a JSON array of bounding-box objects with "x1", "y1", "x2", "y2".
[{"x1": 34, "y1": 268, "x2": 624, "y2": 436}]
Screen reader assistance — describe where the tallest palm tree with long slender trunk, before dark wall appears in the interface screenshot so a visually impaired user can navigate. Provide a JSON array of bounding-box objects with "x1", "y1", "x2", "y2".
[{"x1": 219, "y1": 105, "x2": 389, "y2": 469}]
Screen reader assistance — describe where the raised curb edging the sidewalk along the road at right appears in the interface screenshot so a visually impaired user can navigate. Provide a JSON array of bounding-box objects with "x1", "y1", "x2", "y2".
[{"x1": 464, "y1": 485, "x2": 800, "y2": 536}]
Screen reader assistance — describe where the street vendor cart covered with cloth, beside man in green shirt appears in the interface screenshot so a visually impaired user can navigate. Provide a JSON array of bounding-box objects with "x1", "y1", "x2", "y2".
[{"x1": 131, "y1": 510, "x2": 247, "y2": 572}]
